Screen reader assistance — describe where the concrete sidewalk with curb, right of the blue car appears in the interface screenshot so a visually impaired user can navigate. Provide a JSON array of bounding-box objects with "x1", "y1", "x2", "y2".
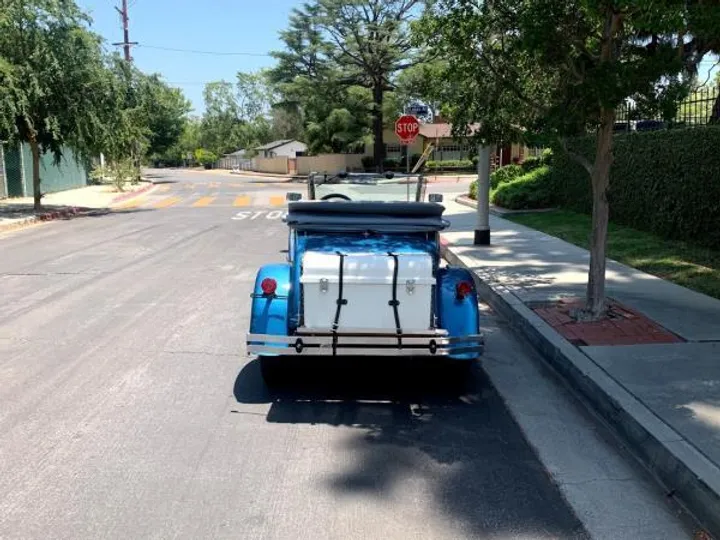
[{"x1": 443, "y1": 202, "x2": 720, "y2": 537}]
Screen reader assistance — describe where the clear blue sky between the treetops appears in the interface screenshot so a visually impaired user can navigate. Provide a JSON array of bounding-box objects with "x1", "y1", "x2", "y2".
[{"x1": 78, "y1": 0, "x2": 302, "y2": 114}]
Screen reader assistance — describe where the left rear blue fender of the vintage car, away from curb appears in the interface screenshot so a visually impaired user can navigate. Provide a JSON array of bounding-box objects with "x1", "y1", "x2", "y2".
[{"x1": 250, "y1": 264, "x2": 293, "y2": 354}]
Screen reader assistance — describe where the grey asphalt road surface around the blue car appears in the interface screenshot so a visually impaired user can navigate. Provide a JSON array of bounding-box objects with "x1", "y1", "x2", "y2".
[{"x1": 0, "y1": 172, "x2": 688, "y2": 540}]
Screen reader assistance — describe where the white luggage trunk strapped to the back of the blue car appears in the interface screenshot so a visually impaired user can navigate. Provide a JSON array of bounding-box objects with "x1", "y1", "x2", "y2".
[{"x1": 300, "y1": 251, "x2": 435, "y2": 333}]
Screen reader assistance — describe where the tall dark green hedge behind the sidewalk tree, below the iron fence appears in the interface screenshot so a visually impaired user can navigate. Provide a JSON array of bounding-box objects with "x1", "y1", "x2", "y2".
[{"x1": 552, "y1": 126, "x2": 720, "y2": 248}]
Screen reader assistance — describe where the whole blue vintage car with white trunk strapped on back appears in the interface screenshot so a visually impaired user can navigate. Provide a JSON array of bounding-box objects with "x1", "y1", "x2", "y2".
[{"x1": 247, "y1": 174, "x2": 483, "y2": 386}]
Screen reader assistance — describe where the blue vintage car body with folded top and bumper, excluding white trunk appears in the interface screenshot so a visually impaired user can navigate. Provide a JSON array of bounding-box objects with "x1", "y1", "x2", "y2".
[{"x1": 247, "y1": 175, "x2": 484, "y2": 361}]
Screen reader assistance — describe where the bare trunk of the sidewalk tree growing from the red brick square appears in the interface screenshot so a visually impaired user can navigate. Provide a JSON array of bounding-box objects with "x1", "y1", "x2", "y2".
[{"x1": 585, "y1": 109, "x2": 615, "y2": 320}]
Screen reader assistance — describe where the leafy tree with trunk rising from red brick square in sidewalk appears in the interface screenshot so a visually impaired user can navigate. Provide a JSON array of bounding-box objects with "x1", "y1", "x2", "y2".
[{"x1": 419, "y1": 0, "x2": 720, "y2": 318}]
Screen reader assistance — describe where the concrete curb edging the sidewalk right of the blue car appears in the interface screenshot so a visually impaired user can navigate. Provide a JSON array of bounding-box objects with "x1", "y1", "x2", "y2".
[{"x1": 441, "y1": 240, "x2": 720, "y2": 538}]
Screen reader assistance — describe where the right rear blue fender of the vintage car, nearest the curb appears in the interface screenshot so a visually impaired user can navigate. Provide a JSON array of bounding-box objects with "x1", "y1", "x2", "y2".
[{"x1": 437, "y1": 267, "x2": 480, "y2": 360}]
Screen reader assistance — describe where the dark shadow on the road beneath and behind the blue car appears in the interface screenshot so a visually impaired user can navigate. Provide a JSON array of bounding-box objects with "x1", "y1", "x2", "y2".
[{"x1": 235, "y1": 358, "x2": 587, "y2": 538}]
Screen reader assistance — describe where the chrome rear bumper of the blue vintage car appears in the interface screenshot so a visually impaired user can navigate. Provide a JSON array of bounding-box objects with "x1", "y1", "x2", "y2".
[{"x1": 247, "y1": 329, "x2": 485, "y2": 356}]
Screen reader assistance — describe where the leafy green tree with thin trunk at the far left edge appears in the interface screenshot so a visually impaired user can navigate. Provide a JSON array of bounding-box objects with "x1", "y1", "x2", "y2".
[{"x1": 0, "y1": 0, "x2": 112, "y2": 210}]
